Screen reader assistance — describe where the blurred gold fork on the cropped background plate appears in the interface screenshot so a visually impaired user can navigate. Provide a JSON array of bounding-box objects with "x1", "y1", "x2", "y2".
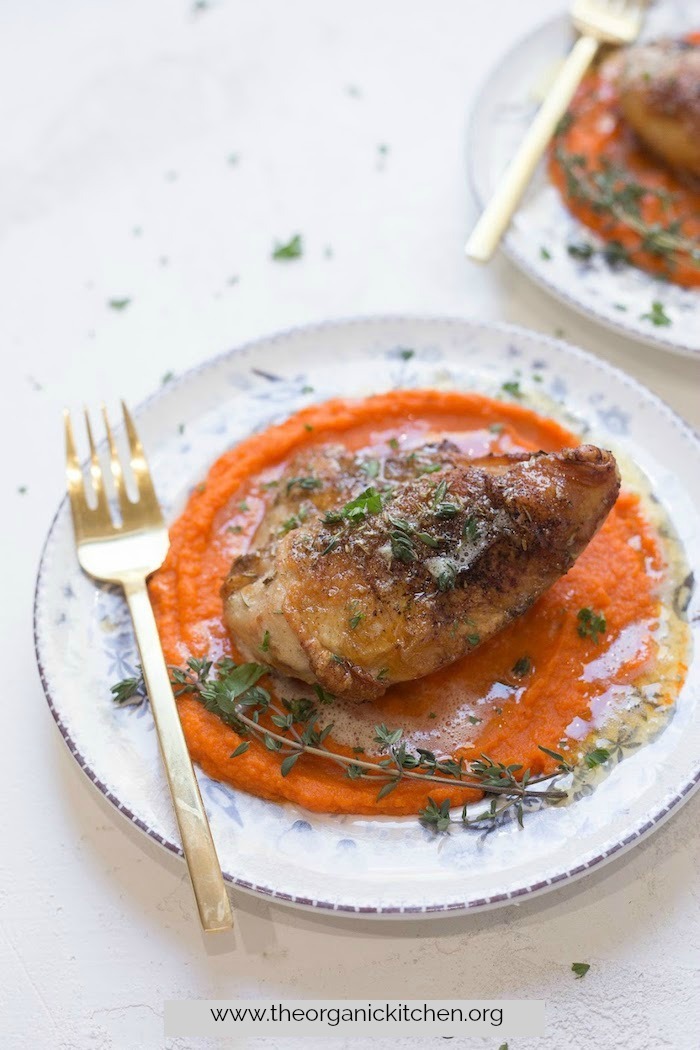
[{"x1": 465, "y1": 0, "x2": 645, "y2": 263}]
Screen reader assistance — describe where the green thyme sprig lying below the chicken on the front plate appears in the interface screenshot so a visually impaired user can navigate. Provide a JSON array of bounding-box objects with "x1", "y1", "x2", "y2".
[{"x1": 111, "y1": 657, "x2": 573, "y2": 831}]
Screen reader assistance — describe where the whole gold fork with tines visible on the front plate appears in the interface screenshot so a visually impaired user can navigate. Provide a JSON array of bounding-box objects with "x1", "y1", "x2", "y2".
[{"x1": 65, "y1": 402, "x2": 233, "y2": 931}]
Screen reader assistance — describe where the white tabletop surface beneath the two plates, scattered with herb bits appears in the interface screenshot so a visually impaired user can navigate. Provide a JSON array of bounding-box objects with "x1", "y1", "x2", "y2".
[{"x1": 5, "y1": 0, "x2": 700, "y2": 1050}]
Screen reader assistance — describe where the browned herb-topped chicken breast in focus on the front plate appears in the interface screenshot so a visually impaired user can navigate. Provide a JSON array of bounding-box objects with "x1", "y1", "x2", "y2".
[{"x1": 222, "y1": 442, "x2": 619, "y2": 700}]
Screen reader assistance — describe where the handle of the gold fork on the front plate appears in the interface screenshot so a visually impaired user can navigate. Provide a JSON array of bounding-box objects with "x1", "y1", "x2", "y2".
[{"x1": 124, "y1": 579, "x2": 233, "y2": 931}]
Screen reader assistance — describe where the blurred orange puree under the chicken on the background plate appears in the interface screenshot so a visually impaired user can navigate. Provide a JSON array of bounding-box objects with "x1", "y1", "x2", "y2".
[{"x1": 549, "y1": 57, "x2": 700, "y2": 288}]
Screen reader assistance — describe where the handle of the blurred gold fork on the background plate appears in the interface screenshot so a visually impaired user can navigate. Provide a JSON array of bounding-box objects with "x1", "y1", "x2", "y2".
[{"x1": 465, "y1": 36, "x2": 599, "y2": 263}]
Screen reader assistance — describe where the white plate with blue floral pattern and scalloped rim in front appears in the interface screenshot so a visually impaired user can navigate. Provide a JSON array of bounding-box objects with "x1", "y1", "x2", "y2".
[{"x1": 35, "y1": 317, "x2": 700, "y2": 917}]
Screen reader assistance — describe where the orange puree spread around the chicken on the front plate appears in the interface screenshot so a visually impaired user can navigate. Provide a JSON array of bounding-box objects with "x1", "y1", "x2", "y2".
[{"x1": 150, "y1": 391, "x2": 673, "y2": 814}]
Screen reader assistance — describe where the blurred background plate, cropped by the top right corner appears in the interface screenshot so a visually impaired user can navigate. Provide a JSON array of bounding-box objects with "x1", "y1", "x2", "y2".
[{"x1": 468, "y1": 0, "x2": 700, "y2": 356}]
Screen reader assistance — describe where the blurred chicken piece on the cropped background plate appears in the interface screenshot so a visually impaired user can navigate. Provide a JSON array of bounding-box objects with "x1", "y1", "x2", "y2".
[{"x1": 618, "y1": 40, "x2": 700, "y2": 177}]
